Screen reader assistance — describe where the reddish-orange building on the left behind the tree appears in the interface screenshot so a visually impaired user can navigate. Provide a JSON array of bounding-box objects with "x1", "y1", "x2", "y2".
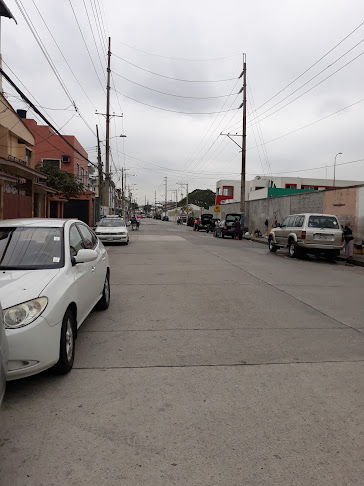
[{"x1": 18, "y1": 110, "x2": 95, "y2": 226}]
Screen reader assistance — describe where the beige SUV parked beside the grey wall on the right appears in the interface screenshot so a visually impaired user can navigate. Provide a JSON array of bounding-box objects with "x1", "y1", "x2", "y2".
[{"x1": 268, "y1": 213, "x2": 344, "y2": 260}]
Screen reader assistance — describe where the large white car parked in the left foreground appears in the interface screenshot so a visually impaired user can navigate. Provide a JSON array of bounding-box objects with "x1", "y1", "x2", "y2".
[{"x1": 0, "y1": 218, "x2": 110, "y2": 380}]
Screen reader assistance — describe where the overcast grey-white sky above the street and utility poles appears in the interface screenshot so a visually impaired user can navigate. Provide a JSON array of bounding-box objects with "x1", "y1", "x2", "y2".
[{"x1": 1, "y1": 0, "x2": 364, "y2": 204}]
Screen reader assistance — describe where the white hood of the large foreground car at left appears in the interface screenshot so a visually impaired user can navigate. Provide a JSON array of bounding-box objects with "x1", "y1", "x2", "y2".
[{"x1": 0, "y1": 268, "x2": 60, "y2": 309}]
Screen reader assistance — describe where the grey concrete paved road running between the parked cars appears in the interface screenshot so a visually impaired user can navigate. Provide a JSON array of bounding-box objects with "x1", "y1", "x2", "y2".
[{"x1": 0, "y1": 220, "x2": 364, "y2": 486}]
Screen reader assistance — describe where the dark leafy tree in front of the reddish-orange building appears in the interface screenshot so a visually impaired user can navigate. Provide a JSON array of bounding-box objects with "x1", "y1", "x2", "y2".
[{"x1": 37, "y1": 165, "x2": 85, "y2": 199}]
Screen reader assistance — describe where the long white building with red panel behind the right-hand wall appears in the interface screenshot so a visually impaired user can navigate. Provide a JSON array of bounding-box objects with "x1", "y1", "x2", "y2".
[{"x1": 216, "y1": 176, "x2": 364, "y2": 204}]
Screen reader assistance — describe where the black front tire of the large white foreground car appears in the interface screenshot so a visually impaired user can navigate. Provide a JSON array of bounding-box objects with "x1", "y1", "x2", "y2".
[{"x1": 52, "y1": 308, "x2": 76, "y2": 375}]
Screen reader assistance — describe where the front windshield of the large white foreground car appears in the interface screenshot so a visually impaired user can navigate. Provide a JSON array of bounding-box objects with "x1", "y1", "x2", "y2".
[{"x1": 0, "y1": 227, "x2": 64, "y2": 270}]
